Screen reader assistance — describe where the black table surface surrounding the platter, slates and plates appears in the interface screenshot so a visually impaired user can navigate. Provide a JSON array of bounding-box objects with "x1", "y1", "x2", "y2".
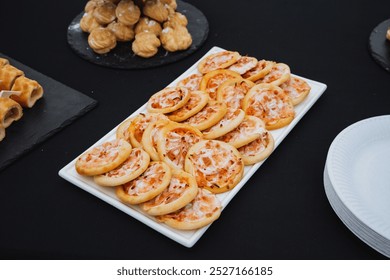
[{"x1": 0, "y1": 0, "x2": 390, "y2": 260}]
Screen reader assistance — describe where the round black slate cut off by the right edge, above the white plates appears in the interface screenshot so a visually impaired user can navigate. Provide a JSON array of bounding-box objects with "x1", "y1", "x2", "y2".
[{"x1": 368, "y1": 19, "x2": 390, "y2": 72}]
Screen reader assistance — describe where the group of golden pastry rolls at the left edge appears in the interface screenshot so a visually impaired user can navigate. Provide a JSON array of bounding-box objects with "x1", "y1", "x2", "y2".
[{"x1": 0, "y1": 57, "x2": 43, "y2": 142}]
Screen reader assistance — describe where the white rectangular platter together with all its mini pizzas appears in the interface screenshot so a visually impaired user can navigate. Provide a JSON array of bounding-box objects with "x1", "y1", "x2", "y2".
[{"x1": 60, "y1": 47, "x2": 326, "y2": 247}]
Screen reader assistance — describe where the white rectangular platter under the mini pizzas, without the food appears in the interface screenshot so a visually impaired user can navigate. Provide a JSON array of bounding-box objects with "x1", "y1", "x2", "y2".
[{"x1": 59, "y1": 47, "x2": 326, "y2": 247}]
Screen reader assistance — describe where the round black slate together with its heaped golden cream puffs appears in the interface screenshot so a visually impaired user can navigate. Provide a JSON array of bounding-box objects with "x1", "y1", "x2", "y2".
[{"x1": 68, "y1": 0, "x2": 208, "y2": 69}]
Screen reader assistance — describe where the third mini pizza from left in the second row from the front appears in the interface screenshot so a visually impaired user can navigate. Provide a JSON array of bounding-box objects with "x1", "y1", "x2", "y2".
[{"x1": 141, "y1": 119, "x2": 170, "y2": 161}]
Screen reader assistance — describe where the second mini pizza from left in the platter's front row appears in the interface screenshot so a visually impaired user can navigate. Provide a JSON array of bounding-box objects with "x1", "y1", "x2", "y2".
[{"x1": 94, "y1": 148, "x2": 150, "y2": 187}]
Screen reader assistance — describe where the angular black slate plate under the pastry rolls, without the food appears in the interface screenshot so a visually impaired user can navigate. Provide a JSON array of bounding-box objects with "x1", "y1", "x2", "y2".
[{"x1": 0, "y1": 53, "x2": 97, "y2": 170}]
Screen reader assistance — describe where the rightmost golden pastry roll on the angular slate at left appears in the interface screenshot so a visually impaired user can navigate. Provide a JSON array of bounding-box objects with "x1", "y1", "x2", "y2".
[{"x1": 10, "y1": 76, "x2": 43, "y2": 108}]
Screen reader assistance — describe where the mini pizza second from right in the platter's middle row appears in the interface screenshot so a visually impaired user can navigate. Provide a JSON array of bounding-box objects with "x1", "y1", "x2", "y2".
[{"x1": 217, "y1": 115, "x2": 265, "y2": 149}]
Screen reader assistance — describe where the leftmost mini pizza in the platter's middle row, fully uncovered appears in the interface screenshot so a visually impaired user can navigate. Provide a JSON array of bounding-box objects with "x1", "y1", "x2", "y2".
[{"x1": 147, "y1": 87, "x2": 190, "y2": 114}]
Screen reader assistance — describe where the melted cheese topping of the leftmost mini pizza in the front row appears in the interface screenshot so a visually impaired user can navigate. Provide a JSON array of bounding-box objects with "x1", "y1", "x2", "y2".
[{"x1": 80, "y1": 139, "x2": 124, "y2": 166}]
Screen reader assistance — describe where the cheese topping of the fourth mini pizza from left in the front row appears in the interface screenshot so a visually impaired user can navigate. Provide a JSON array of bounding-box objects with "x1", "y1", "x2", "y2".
[{"x1": 144, "y1": 174, "x2": 190, "y2": 208}]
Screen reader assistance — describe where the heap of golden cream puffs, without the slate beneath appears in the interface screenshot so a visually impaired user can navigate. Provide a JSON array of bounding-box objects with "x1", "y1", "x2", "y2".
[{"x1": 80, "y1": 0, "x2": 192, "y2": 58}]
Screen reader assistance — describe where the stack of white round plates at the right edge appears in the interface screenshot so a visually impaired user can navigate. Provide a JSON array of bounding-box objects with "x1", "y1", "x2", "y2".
[{"x1": 324, "y1": 115, "x2": 390, "y2": 257}]
